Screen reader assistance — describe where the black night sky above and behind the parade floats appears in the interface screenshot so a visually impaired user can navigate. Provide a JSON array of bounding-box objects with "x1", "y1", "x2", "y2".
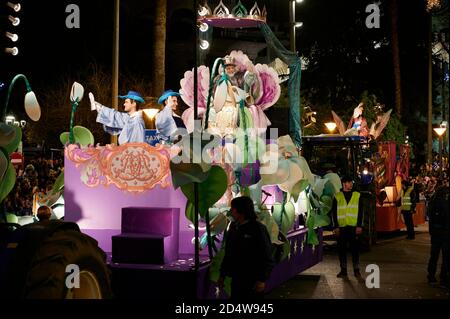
[{"x1": 0, "y1": 0, "x2": 442, "y2": 155}]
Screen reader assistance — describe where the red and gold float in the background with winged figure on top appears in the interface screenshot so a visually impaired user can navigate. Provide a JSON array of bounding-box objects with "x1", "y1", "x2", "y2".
[{"x1": 302, "y1": 101, "x2": 425, "y2": 240}]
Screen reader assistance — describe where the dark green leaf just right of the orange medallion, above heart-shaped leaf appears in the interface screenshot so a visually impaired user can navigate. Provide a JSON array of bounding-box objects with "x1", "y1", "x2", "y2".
[{"x1": 170, "y1": 161, "x2": 210, "y2": 189}]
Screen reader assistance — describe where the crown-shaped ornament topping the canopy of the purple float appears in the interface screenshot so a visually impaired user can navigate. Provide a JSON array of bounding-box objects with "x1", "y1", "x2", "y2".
[{"x1": 197, "y1": 0, "x2": 267, "y2": 22}]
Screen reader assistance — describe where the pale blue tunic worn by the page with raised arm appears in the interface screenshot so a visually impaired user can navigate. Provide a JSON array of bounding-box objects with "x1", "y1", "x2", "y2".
[{"x1": 97, "y1": 106, "x2": 145, "y2": 145}]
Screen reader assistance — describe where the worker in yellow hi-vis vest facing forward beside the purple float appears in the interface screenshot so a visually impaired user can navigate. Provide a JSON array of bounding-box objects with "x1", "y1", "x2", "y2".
[{"x1": 331, "y1": 175, "x2": 363, "y2": 280}]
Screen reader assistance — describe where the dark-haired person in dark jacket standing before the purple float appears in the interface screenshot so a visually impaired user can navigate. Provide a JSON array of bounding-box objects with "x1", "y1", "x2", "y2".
[{"x1": 218, "y1": 196, "x2": 274, "y2": 299}]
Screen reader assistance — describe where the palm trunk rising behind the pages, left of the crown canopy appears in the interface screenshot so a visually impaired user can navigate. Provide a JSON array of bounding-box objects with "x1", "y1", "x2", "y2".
[{"x1": 152, "y1": 0, "x2": 167, "y2": 96}]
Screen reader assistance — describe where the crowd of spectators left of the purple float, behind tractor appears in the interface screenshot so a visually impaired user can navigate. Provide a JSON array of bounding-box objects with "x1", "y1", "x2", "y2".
[{"x1": 5, "y1": 156, "x2": 63, "y2": 216}]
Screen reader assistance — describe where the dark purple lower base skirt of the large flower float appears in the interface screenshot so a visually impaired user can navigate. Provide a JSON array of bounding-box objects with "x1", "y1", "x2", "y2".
[{"x1": 105, "y1": 229, "x2": 323, "y2": 299}]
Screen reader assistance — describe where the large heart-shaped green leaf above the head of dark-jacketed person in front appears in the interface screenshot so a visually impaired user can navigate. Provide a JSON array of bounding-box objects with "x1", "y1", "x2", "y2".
[{"x1": 181, "y1": 166, "x2": 228, "y2": 221}]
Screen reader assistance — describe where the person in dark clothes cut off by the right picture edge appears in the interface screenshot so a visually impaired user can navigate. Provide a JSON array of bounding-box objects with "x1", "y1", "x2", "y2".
[{"x1": 428, "y1": 185, "x2": 449, "y2": 288}]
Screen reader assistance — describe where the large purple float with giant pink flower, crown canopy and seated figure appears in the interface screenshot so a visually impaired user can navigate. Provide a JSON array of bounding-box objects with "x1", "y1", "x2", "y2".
[{"x1": 62, "y1": 2, "x2": 339, "y2": 298}]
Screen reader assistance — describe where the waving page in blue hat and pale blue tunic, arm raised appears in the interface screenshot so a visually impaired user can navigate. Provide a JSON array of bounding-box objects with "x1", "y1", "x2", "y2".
[{"x1": 89, "y1": 91, "x2": 145, "y2": 145}]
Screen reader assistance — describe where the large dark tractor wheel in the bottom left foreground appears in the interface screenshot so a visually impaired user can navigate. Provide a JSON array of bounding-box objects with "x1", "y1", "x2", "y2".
[{"x1": 23, "y1": 230, "x2": 112, "y2": 299}]
